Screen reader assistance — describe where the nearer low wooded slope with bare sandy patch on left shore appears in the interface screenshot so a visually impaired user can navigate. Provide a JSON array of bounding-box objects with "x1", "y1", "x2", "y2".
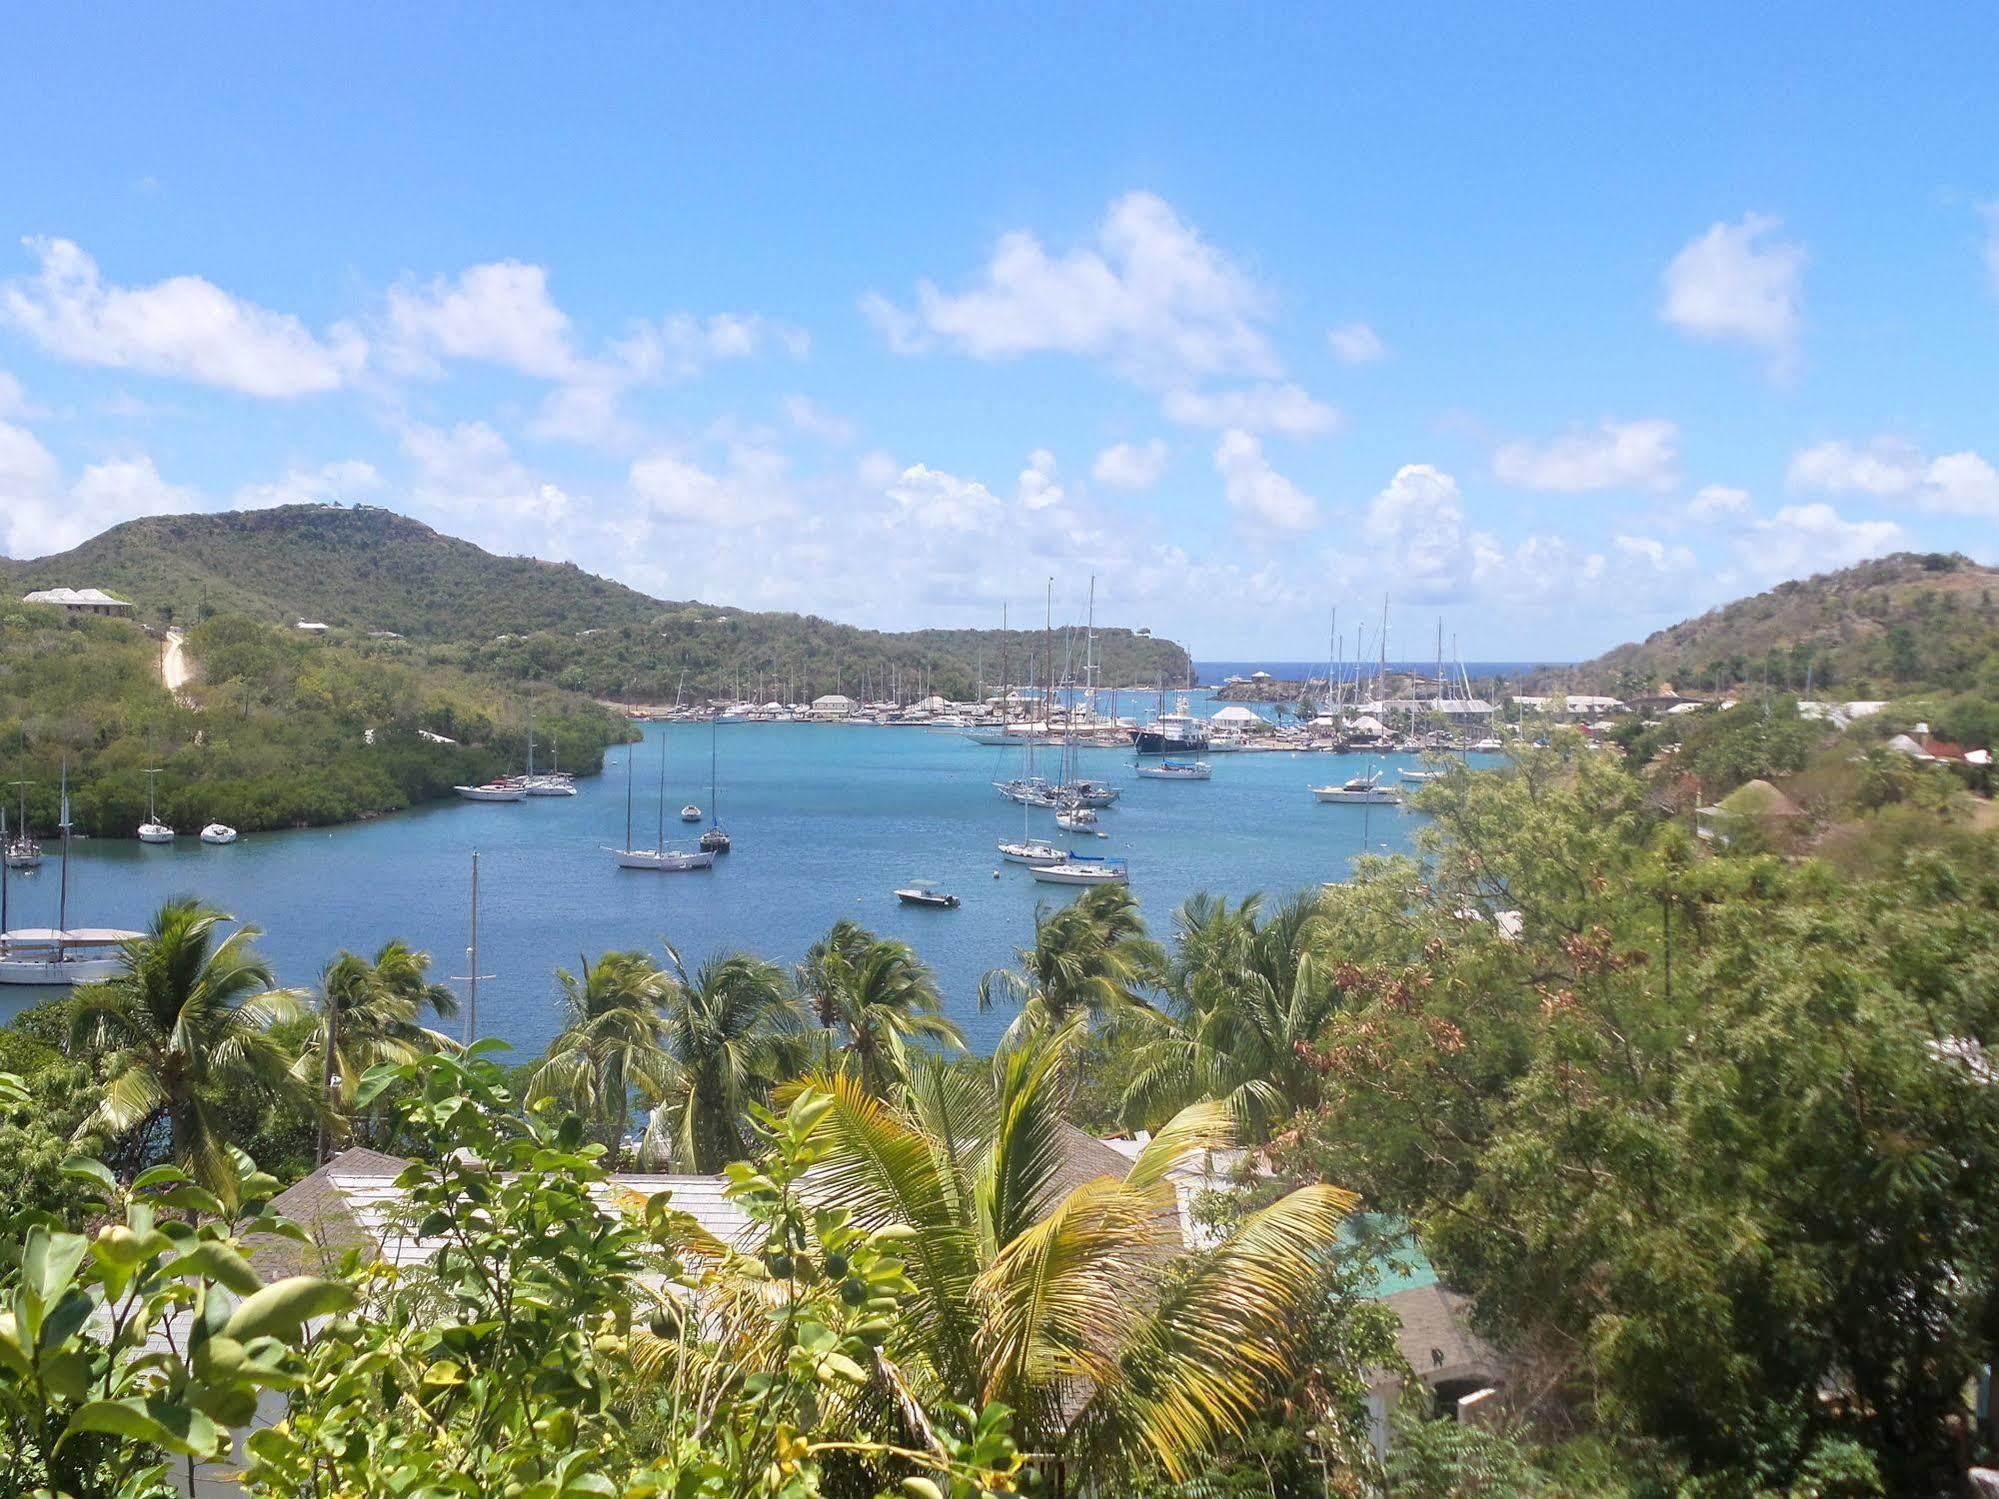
[{"x1": 0, "y1": 604, "x2": 628, "y2": 837}]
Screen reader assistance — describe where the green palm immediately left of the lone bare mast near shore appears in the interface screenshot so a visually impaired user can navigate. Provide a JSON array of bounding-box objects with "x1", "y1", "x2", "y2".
[{"x1": 292, "y1": 937, "x2": 458, "y2": 1157}]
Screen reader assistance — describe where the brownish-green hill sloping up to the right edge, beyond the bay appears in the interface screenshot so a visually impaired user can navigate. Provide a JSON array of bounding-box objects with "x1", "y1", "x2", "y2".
[{"x1": 1569, "y1": 552, "x2": 1999, "y2": 698}]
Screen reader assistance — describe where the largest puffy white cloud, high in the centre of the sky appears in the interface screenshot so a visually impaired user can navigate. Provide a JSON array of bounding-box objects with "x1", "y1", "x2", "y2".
[{"x1": 862, "y1": 192, "x2": 1281, "y2": 382}]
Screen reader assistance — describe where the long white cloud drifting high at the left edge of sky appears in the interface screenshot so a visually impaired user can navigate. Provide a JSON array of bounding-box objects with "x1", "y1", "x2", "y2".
[{"x1": 0, "y1": 240, "x2": 366, "y2": 398}]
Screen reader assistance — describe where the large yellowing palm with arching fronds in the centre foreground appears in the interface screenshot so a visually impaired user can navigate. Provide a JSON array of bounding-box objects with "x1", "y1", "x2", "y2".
[{"x1": 810, "y1": 1017, "x2": 1355, "y2": 1477}]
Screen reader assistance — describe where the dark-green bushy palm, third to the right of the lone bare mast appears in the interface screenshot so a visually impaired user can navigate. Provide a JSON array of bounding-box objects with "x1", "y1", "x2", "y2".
[{"x1": 798, "y1": 919, "x2": 966, "y2": 1093}]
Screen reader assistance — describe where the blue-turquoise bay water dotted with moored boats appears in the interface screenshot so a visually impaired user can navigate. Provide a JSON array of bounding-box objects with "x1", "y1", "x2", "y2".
[{"x1": 0, "y1": 706, "x2": 1487, "y2": 1053}]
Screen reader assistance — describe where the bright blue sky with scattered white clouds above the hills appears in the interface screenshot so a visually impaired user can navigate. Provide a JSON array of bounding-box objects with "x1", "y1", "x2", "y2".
[{"x1": 0, "y1": 4, "x2": 1999, "y2": 658}]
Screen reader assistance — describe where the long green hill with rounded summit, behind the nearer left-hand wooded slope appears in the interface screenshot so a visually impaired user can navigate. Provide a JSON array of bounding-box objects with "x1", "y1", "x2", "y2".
[{"x1": 0, "y1": 506, "x2": 1189, "y2": 702}]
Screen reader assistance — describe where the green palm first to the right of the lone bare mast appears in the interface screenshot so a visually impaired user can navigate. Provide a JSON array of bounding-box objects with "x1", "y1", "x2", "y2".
[{"x1": 528, "y1": 951, "x2": 674, "y2": 1171}]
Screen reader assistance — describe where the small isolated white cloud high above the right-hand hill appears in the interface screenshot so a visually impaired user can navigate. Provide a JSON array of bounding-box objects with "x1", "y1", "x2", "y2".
[{"x1": 1659, "y1": 214, "x2": 1807, "y2": 364}]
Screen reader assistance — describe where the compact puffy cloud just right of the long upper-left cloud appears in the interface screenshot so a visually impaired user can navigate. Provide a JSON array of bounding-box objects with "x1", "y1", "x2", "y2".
[{"x1": 386, "y1": 260, "x2": 578, "y2": 380}]
